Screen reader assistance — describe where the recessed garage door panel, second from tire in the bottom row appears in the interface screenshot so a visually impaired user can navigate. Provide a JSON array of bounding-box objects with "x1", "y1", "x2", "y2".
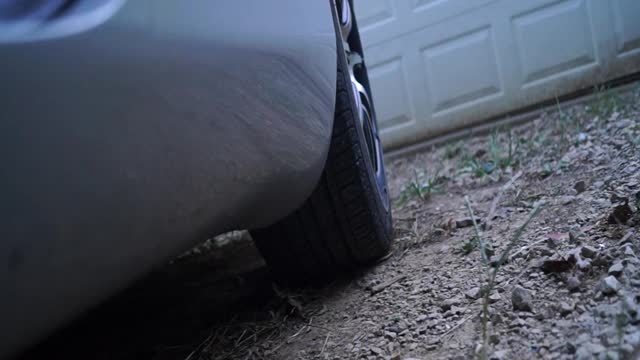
[{"x1": 421, "y1": 26, "x2": 501, "y2": 115}]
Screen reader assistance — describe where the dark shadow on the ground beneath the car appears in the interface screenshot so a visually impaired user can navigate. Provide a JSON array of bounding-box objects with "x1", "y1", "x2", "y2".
[{"x1": 18, "y1": 236, "x2": 282, "y2": 360}]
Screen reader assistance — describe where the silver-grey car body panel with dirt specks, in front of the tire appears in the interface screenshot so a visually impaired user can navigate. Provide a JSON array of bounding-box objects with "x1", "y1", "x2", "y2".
[{"x1": 0, "y1": 0, "x2": 336, "y2": 357}]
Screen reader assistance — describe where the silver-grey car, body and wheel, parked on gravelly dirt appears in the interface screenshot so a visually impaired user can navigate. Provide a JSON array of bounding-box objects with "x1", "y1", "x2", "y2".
[{"x1": 0, "y1": 0, "x2": 392, "y2": 357}]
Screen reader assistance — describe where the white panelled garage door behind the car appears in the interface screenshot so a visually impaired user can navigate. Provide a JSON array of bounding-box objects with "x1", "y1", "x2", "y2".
[{"x1": 355, "y1": 0, "x2": 640, "y2": 147}]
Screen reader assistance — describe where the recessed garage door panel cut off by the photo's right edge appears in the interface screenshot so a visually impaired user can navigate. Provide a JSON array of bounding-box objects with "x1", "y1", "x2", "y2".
[{"x1": 611, "y1": 0, "x2": 640, "y2": 55}]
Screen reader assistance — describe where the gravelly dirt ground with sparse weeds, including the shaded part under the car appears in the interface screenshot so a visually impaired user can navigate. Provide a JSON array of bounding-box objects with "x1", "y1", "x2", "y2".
[{"x1": 24, "y1": 85, "x2": 640, "y2": 360}]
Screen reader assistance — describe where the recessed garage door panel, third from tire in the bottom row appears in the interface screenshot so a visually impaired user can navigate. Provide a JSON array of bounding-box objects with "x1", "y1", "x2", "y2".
[{"x1": 513, "y1": 0, "x2": 596, "y2": 84}]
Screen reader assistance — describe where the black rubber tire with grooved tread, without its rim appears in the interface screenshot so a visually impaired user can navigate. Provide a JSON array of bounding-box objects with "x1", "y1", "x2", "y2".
[{"x1": 251, "y1": 5, "x2": 392, "y2": 284}]
